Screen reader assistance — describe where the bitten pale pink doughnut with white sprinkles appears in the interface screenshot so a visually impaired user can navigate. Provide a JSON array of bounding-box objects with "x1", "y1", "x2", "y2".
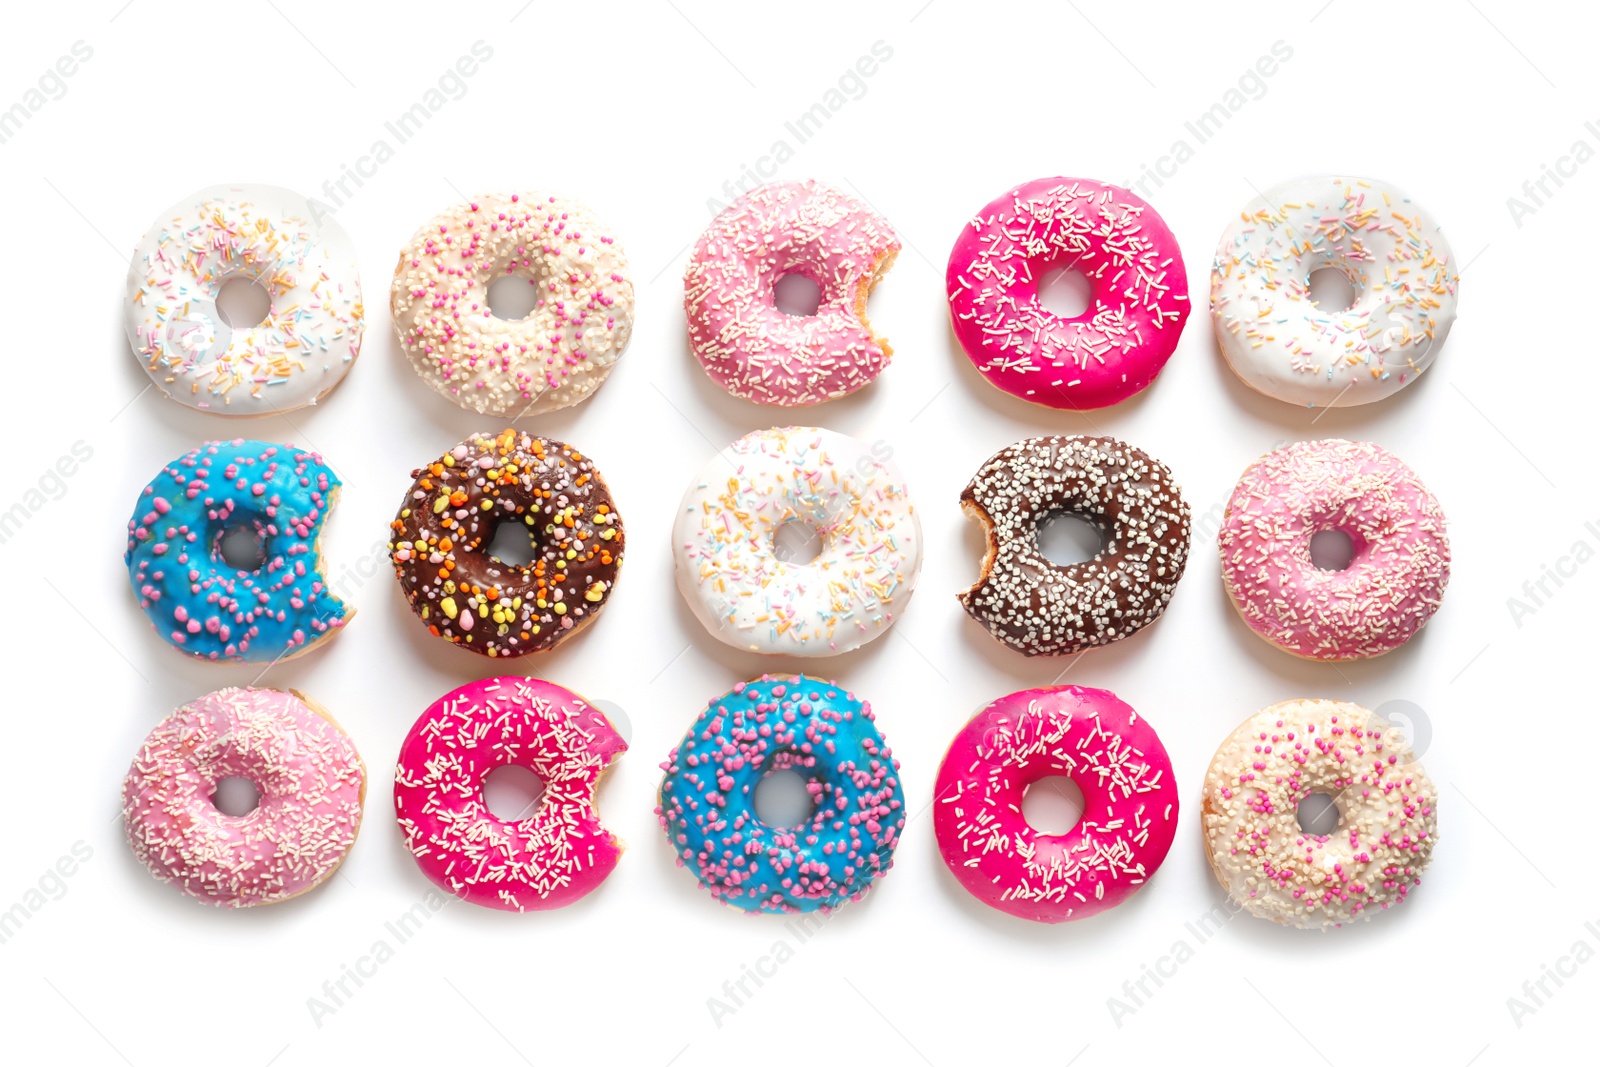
[{"x1": 683, "y1": 181, "x2": 901, "y2": 408}]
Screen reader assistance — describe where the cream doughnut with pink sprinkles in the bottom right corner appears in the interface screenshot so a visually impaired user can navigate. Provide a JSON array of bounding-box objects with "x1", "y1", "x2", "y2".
[{"x1": 1202, "y1": 699, "x2": 1438, "y2": 929}]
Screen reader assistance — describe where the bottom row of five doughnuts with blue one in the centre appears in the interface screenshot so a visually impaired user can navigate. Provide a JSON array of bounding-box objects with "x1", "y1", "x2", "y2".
[{"x1": 123, "y1": 675, "x2": 1438, "y2": 929}]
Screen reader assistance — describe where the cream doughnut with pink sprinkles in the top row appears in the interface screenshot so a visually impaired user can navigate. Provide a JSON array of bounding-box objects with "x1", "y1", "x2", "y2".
[{"x1": 389, "y1": 194, "x2": 634, "y2": 418}]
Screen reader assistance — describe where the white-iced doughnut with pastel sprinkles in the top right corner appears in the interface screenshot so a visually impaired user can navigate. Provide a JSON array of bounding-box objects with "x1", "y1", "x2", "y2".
[{"x1": 1211, "y1": 176, "x2": 1461, "y2": 408}]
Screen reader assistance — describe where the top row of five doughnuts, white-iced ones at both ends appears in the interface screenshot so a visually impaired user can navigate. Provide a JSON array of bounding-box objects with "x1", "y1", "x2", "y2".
[{"x1": 125, "y1": 176, "x2": 1459, "y2": 418}]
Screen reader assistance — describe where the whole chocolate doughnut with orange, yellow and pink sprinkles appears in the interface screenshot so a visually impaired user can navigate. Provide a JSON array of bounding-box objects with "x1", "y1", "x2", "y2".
[{"x1": 389, "y1": 429, "x2": 626, "y2": 657}]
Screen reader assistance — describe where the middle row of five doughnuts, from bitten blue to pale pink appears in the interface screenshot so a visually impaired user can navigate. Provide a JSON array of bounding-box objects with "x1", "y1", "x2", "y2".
[{"x1": 125, "y1": 427, "x2": 1450, "y2": 664}]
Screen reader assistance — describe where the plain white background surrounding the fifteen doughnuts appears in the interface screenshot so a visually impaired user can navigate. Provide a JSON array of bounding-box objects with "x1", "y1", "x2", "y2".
[{"x1": 0, "y1": 0, "x2": 1600, "y2": 1067}]
